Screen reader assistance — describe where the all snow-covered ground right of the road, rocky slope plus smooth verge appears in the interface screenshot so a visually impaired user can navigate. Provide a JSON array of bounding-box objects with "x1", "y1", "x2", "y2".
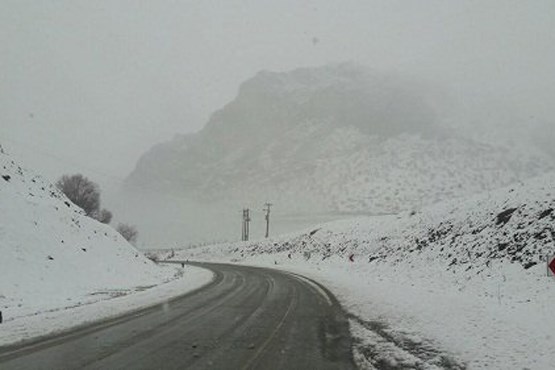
[{"x1": 176, "y1": 174, "x2": 555, "y2": 369}]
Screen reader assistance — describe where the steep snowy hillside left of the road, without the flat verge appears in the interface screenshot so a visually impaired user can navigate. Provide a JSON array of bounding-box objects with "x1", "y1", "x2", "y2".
[{"x1": 0, "y1": 147, "x2": 175, "y2": 322}]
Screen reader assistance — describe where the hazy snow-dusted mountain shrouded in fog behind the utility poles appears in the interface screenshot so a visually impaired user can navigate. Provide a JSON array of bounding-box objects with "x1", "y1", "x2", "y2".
[{"x1": 120, "y1": 63, "x2": 553, "y2": 243}]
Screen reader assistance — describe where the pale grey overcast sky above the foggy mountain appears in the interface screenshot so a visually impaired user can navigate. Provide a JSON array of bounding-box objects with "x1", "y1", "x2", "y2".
[{"x1": 0, "y1": 0, "x2": 555, "y2": 189}]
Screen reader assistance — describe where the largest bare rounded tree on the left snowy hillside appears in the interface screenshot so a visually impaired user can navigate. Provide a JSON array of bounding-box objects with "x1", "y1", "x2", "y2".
[{"x1": 56, "y1": 174, "x2": 100, "y2": 217}]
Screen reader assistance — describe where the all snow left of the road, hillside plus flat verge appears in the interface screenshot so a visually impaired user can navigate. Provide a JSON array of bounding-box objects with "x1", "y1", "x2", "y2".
[{"x1": 0, "y1": 147, "x2": 212, "y2": 345}]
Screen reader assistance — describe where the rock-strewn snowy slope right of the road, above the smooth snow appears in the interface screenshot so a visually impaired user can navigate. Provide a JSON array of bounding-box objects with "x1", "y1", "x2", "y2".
[{"x1": 236, "y1": 173, "x2": 555, "y2": 276}]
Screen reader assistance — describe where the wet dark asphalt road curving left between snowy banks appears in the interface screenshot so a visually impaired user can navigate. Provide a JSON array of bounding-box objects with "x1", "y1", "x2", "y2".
[{"x1": 0, "y1": 264, "x2": 355, "y2": 370}]
